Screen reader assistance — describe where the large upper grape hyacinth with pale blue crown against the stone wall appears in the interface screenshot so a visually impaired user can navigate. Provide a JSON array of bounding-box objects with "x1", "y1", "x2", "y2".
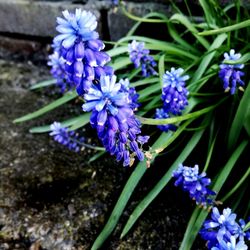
[{"x1": 53, "y1": 9, "x2": 113, "y2": 96}]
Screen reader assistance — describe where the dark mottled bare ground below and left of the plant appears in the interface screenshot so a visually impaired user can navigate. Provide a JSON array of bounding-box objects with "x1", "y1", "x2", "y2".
[{"x1": 0, "y1": 55, "x2": 205, "y2": 250}]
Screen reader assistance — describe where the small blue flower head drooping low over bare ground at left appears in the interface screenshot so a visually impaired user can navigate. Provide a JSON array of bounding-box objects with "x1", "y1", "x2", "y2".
[{"x1": 50, "y1": 122, "x2": 84, "y2": 152}]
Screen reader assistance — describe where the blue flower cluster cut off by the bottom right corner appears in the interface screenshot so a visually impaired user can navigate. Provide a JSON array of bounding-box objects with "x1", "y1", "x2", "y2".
[{"x1": 200, "y1": 207, "x2": 250, "y2": 250}]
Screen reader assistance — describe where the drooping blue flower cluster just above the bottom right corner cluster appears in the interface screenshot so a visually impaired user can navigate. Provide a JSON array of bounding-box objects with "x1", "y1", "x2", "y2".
[{"x1": 173, "y1": 164, "x2": 216, "y2": 207}]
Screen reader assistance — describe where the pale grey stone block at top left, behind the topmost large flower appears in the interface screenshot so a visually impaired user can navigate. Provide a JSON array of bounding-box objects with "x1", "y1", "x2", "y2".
[{"x1": 0, "y1": 0, "x2": 101, "y2": 37}]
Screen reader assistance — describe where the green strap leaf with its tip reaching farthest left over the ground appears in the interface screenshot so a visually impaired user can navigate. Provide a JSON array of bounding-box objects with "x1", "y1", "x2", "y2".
[{"x1": 13, "y1": 91, "x2": 77, "y2": 123}]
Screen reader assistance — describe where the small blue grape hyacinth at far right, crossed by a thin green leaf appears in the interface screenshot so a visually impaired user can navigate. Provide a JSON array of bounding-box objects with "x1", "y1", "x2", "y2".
[{"x1": 219, "y1": 49, "x2": 245, "y2": 95}]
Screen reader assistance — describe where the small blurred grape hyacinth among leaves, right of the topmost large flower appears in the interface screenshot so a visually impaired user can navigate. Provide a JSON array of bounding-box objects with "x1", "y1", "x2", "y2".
[{"x1": 128, "y1": 40, "x2": 157, "y2": 77}]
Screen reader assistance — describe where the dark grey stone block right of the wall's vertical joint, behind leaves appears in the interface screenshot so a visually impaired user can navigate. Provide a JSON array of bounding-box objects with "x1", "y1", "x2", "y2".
[{"x1": 108, "y1": 3, "x2": 171, "y2": 41}]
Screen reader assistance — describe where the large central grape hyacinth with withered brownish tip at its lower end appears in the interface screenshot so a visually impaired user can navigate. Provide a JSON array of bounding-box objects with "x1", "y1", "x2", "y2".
[{"x1": 82, "y1": 75, "x2": 148, "y2": 166}]
